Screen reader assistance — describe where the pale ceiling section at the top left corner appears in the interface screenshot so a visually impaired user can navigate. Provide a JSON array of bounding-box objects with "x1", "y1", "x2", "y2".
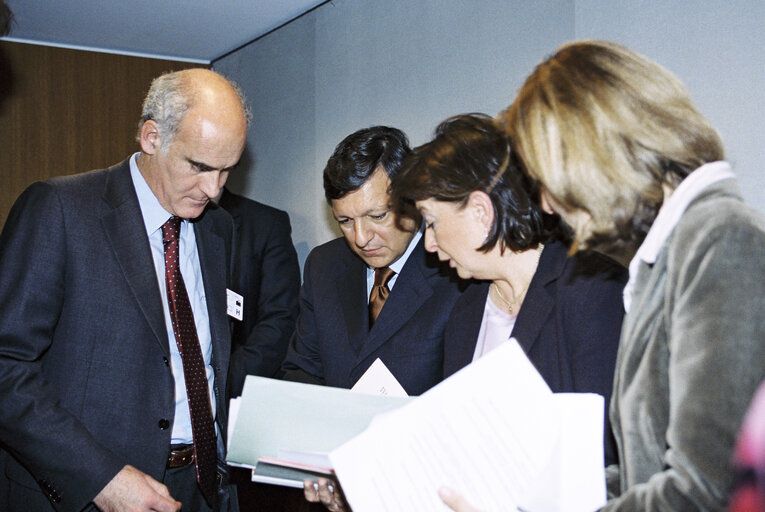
[{"x1": 3, "y1": 0, "x2": 327, "y2": 64}]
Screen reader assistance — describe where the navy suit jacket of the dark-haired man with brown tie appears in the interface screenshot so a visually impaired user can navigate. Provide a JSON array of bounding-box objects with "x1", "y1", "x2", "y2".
[{"x1": 283, "y1": 238, "x2": 461, "y2": 395}]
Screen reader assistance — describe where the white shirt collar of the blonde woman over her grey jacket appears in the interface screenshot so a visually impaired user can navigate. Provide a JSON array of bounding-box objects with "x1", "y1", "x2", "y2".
[{"x1": 624, "y1": 161, "x2": 735, "y2": 312}]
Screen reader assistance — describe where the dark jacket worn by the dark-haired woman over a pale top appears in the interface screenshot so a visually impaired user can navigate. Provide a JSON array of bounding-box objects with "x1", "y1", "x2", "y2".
[{"x1": 444, "y1": 242, "x2": 627, "y2": 463}]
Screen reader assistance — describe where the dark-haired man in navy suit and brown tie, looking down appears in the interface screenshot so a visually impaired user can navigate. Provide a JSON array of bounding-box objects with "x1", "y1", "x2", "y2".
[{"x1": 282, "y1": 126, "x2": 460, "y2": 395}]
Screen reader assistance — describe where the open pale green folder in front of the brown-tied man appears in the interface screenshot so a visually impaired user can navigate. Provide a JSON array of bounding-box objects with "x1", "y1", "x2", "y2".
[{"x1": 227, "y1": 375, "x2": 411, "y2": 487}]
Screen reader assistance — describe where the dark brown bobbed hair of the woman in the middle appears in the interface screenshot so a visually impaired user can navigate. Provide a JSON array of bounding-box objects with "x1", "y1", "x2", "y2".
[{"x1": 391, "y1": 113, "x2": 559, "y2": 251}]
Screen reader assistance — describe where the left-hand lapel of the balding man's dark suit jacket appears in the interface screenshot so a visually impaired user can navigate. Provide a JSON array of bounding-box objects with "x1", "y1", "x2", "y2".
[{"x1": 101, "y1": 160, "x2": 170, "y2": 356}]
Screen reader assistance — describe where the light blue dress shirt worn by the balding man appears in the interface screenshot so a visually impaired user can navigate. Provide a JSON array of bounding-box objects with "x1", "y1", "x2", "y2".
[{"x1": 130, "y1": 153, "x2": 215, "y2": 444}]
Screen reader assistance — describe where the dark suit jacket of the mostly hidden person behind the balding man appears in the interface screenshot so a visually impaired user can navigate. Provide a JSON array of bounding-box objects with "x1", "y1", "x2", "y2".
[{"x1": 218, "y1": 190, "x2": 300, "y2": 396}]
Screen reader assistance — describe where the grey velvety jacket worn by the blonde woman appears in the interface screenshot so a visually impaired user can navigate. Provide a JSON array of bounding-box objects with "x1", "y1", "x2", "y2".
[{"x1": 605, "y1": 180, "x2": 765, "y2": 511}]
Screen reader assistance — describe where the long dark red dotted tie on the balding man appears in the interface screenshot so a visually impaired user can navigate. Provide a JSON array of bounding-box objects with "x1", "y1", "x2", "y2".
[{"x1": 162, "y1": 217, "x2": 217, "y2": 505}]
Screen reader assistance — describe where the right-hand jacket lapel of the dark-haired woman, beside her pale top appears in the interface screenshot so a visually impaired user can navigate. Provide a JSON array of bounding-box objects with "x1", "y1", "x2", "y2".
[{"x1": 512, "y1": 242, "x2": 566, "y2": 354}]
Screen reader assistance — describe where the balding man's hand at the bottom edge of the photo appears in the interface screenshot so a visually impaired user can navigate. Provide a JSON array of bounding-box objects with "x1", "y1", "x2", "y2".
[{"x1": 93, "y1": 466, "x2": 181, "y2": 512}]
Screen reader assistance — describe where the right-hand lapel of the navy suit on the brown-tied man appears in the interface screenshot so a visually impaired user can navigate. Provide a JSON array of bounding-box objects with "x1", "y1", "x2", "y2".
[{"x1": 358, "y1": 239, "x2": 438, "y2": 361}]
